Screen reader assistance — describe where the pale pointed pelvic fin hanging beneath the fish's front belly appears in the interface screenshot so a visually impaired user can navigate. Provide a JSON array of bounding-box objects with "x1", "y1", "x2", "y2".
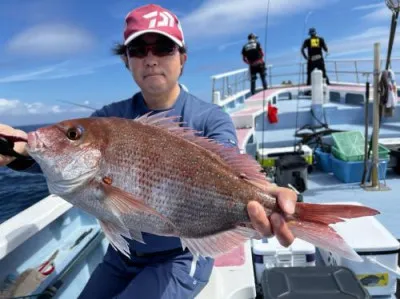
[{"x1": 99, "y1": 220, "x2": 131, "y2": 258}]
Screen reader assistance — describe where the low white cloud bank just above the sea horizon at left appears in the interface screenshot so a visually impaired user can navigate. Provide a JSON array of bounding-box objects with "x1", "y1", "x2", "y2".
[{"x1": 0, "y1": 99, "x2": 92, "y2": 116}]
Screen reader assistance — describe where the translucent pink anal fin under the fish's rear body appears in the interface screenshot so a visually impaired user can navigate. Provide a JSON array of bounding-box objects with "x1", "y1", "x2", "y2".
[{"x1": 181, "y1": 226, "x2": 258, "y2": 258}]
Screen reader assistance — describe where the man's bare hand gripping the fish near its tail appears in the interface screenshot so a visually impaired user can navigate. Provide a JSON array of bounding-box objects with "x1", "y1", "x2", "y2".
[{"x1": 247, "y1": 185, "x2": 297, "y2": 246}]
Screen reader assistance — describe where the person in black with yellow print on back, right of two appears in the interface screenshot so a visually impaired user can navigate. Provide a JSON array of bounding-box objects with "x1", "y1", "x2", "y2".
[{"x1": 301, "y1": 28, "x2": 329, "y2": 85}]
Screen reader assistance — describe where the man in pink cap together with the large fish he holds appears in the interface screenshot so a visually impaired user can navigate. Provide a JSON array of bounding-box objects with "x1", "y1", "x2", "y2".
[{"x1": 0, "y1": 4, "x2": 376, "y2": 299}]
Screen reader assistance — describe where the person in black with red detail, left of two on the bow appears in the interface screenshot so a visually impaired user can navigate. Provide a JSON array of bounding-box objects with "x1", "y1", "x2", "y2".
[{"x1": 242, "y1": 33, "x2": 267, "y2": 94}]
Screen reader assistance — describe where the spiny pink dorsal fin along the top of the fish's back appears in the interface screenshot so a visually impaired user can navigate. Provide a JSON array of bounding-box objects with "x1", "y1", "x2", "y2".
[{"x1": 135, "y1": 111, "x2": 270, "y2": 189}]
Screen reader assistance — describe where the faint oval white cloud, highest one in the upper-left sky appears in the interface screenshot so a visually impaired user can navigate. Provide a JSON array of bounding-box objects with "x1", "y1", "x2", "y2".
[{"x1": 7, "y1": 24, "x2": 95, "y2": 56}]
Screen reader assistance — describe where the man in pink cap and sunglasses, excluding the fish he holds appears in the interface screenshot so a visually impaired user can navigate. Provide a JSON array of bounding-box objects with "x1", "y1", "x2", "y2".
[{"x1": 0, "y1": 4, "x2": 297, "y2": 299}]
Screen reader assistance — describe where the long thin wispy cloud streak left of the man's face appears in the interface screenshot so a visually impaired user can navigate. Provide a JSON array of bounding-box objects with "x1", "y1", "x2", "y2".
[{"x1": 0, "y1": 57, "x2": 121, "y2": 83}]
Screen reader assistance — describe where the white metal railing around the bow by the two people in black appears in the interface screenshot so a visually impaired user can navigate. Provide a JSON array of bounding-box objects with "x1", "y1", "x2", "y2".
[{"x1": 211, "y1": 58, "x2": 400, "y2": 106}]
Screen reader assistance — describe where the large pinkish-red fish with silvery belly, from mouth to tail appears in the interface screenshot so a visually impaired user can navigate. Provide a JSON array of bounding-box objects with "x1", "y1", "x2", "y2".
[{"x1": 23, "y1": 113, "x2": 379, "y2": 261}]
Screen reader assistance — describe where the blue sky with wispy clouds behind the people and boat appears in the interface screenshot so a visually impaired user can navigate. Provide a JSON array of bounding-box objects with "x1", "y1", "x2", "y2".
[{"x1": 0, "y1": 0, "x2": 398, "y2": 125}]
